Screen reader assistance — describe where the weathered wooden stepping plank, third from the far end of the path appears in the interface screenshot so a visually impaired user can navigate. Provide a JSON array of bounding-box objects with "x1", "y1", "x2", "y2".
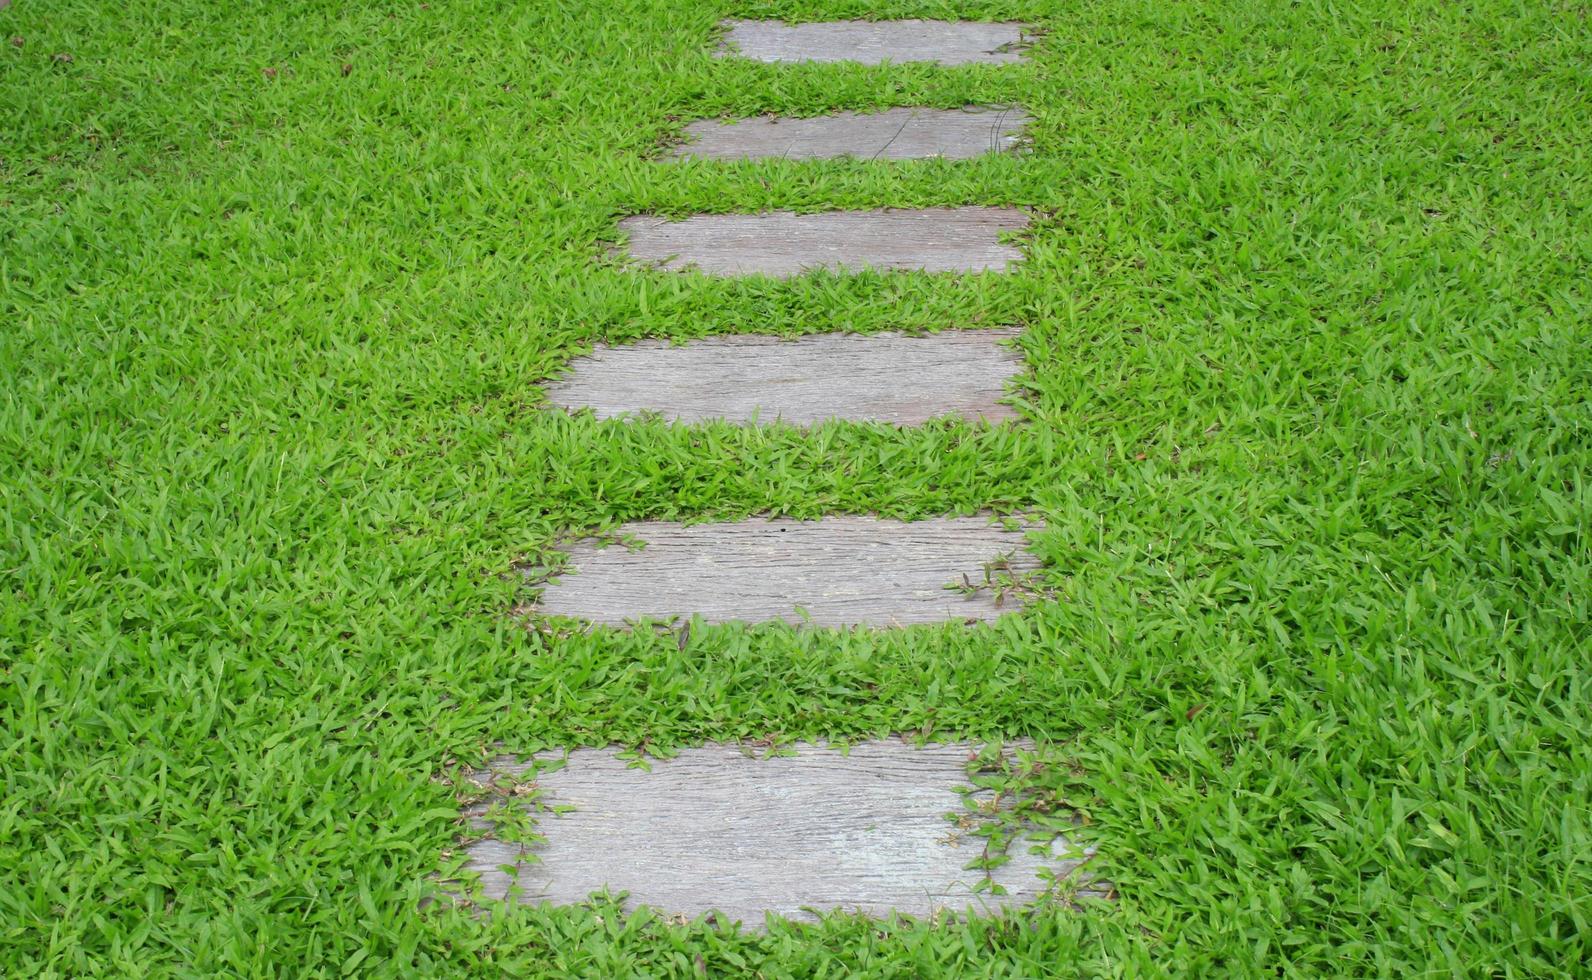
[{"x1": 619, "y1": 207, "x2": 1028, "y2": 277}]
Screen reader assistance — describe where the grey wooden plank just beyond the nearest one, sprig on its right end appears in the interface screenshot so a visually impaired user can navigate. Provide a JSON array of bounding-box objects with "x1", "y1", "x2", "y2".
[{"x1": 537, "y1": 517, "x2": 1040, "y2": 627}]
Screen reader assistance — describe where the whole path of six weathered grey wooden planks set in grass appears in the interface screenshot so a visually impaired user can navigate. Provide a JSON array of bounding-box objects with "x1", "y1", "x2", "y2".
[{"x1": 468, "y1": 21, "x2": 1084, "y2": 926}]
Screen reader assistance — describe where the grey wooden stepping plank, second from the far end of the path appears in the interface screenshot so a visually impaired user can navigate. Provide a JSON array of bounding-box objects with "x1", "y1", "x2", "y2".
[{"x1": 675, "y1": 108, "x2": 1028, "y2": 161}]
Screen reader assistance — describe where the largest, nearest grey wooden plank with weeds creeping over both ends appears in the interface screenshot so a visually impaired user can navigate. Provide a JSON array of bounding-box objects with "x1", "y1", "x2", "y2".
[{"x1": 458, "y1": 733, "x2": 1114, "y2": 932}]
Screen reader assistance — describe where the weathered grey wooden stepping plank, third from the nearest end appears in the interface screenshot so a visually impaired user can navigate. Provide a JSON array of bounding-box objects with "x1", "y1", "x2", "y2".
[{"x1": 548, "y1": 329, "x2": 1022, "y2": 425}]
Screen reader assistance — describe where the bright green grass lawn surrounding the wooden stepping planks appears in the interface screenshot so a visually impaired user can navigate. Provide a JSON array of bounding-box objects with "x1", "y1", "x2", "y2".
[{"x1": 0, "y1": 0, "x2": 1592, "y2": 977}]
